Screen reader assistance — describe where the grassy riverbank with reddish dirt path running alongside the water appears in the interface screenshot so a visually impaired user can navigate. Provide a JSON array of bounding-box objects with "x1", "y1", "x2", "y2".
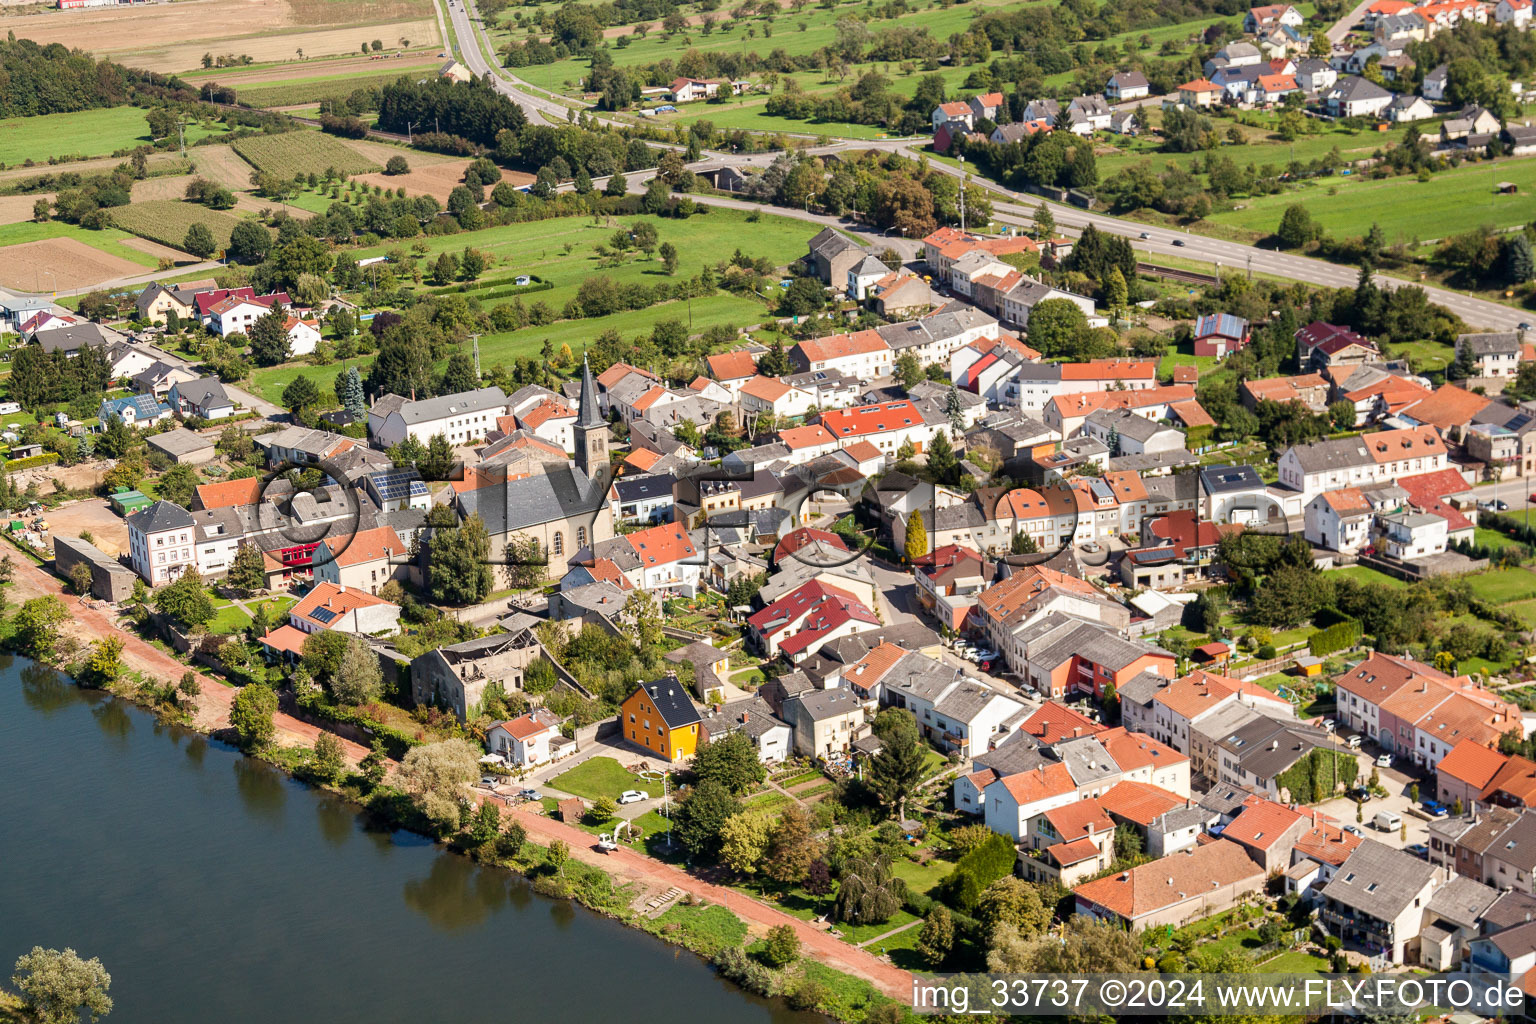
[{"x1": 0, "y1": 559, "x2": 911, "y2": 1024}]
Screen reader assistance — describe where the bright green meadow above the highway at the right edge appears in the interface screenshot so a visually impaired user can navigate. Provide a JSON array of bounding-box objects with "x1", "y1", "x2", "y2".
[{"x1": 1204, "y1": 160, "x2": 1536, "y2": 244}]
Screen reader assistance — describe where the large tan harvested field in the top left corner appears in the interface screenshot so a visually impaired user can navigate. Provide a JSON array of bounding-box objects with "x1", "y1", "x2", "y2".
[{"x1": 0, "y1": 0, "x2": 439, "y2": 72}]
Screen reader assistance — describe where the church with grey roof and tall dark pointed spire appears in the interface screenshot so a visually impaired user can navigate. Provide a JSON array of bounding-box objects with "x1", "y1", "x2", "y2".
[{"x1": 455, "y1": 361, "x2": 614, "y2": 579}]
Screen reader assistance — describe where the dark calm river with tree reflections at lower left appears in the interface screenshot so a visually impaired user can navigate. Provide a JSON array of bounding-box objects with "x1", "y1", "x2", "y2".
[{"x1": 0, "y1": 657, "x2": 823, "y2": 1024}]
